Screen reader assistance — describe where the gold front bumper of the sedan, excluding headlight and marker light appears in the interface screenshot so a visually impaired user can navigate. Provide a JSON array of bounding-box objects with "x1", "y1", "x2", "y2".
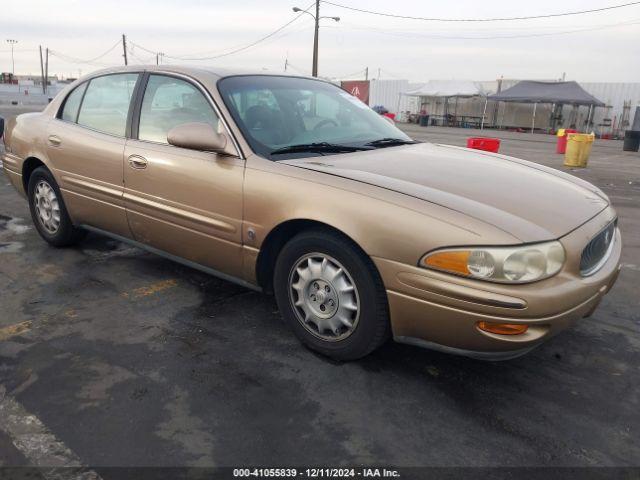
[{"x1": 374, "y1": 208, "x2": 622, "y2": 359}]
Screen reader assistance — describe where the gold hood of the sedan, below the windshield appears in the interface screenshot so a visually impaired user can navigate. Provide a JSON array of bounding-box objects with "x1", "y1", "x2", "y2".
[{"x1": 282, "y1": 143, "x2": 609, "y2": 242}]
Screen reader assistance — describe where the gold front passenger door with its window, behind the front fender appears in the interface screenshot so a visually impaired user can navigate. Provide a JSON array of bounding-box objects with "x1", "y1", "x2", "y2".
[{"x1": 124, "y1": 74, "x2": 244, "y2": 277}]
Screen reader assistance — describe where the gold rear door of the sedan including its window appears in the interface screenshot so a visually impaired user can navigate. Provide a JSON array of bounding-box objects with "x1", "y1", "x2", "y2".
[{"x1": 47, "y1": 73, "x2": 140, "y2": 237}]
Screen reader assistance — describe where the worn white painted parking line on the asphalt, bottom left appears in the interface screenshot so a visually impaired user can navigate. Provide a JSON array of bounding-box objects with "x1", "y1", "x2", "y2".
[{"x1": 0, "y1": 385, "x2": 101, "y2": 480}]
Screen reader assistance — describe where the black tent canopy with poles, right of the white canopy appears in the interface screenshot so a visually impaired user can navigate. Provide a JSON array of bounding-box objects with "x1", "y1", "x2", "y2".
[{"x1": 481, "y1": 80, "x2": 605, "y2": 133}]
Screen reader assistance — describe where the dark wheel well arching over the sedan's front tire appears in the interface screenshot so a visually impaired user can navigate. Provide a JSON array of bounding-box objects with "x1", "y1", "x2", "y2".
[{"x1": 256, "y1": 219, "x2": 364, "y2": 293}]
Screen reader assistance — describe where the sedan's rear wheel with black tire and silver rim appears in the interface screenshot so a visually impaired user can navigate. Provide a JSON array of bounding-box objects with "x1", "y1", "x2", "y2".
[{"x1": 27, "y1": 167, "x2": 86, "y2": 247}]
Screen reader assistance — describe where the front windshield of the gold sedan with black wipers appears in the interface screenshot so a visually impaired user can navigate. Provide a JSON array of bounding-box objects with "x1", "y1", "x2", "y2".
[{"x1": 218, "y1": 75, "x2": 412, "y2": 160}]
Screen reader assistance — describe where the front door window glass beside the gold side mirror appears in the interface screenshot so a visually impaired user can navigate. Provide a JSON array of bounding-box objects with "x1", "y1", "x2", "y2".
[{"x1": 138, "y1": 75, "x2": 220, "y2": 143}]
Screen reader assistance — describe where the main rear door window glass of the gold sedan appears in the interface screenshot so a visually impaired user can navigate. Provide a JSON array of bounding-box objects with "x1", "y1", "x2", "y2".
[{"x1": 78, "y1": 73, "x2": 138, "y2": 137}]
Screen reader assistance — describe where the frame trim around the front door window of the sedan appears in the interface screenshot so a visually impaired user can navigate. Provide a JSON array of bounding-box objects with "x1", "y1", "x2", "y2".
[{"x1": 130, "y1": 70, "x2": 246, "y2": 160}]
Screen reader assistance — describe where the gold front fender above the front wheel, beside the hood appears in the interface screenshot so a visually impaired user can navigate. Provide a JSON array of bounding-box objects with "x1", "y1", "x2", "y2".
[{"x1": 243, "y1": 157, "x2": 520, "y2": 265}]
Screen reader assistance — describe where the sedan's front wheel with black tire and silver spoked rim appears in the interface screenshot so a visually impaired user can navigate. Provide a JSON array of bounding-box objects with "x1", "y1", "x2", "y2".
[{"x1": 274, "y1": 230, "x2": 390, "y2": 360}]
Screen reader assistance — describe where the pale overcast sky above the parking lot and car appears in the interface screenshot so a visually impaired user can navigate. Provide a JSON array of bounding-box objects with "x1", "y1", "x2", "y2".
[{"x1": 0, "y1": 0, "x2": 640, "y2": 83}]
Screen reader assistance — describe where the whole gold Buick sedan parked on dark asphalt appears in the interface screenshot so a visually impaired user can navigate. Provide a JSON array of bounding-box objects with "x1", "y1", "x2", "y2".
[{"x1": 2, "y1": 66, "x2": 621, "y2": 360}]
